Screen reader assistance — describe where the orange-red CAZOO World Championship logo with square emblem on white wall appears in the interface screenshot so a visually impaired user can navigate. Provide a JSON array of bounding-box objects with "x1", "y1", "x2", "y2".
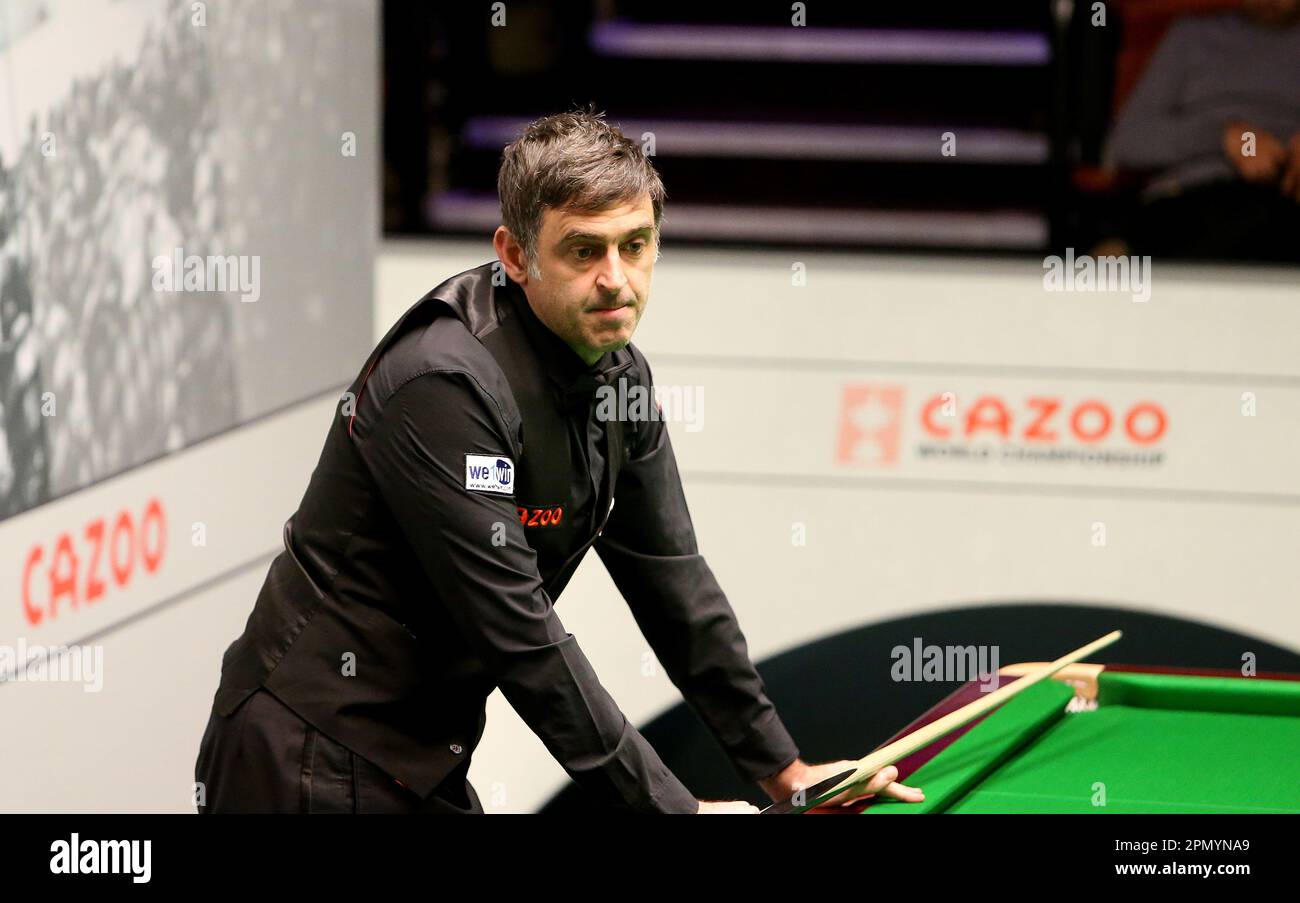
[{"x1": 835, "y1": 383, "x2": 1170, "y2": 468}]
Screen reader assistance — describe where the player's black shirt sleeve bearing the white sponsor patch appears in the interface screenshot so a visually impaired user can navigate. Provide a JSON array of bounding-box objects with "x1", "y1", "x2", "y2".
[{"x1": 360, "y1": 370, "x2": 698, "y2": 813}]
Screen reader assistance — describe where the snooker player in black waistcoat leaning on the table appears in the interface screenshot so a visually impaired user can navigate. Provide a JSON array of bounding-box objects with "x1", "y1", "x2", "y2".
[{"x1": 196, "y1": 113, "x2": 920, "y2": 813}]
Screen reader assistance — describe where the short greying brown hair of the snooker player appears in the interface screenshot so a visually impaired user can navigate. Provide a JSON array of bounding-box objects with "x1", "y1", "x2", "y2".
[{"x1": 497, "y1": 107, "x2": 667, "y2": 278}]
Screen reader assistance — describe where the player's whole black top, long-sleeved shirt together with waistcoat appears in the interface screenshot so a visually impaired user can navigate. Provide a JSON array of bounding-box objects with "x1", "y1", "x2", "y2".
[{"x1": 218, "y1": 265, "x2": 798, "y2": 812}]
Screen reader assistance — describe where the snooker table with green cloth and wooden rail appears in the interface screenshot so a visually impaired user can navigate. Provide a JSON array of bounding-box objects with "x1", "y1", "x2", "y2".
[{"x1": 837, "y1": 663, "x2": 1300, "y2": 815}]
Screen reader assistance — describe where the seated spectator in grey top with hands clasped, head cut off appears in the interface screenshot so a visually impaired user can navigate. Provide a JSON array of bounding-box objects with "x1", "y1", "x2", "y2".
[{"x1": 1109, "y1": 0, "x2": 1300, "y2": 261}]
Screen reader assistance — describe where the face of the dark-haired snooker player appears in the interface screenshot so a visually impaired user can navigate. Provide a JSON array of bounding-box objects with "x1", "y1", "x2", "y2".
[{"x1": 501, "y1": 195, "x2": 658, "y2": 364}]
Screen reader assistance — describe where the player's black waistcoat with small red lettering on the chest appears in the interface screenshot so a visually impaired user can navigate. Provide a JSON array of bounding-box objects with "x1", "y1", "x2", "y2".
[{"x1": 206, "y1": 265, "x2": 640, "y2": 796}]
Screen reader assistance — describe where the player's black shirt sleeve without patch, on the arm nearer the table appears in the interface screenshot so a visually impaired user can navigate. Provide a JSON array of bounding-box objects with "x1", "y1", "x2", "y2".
[{"x1": 595, "y1": 368, "x2": 800, "y2": 781}]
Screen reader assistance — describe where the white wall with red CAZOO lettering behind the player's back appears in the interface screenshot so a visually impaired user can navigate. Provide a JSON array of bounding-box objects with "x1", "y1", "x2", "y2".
[{"x1": 0, "y1": 390, "x2": 342, "y2": 812}]
